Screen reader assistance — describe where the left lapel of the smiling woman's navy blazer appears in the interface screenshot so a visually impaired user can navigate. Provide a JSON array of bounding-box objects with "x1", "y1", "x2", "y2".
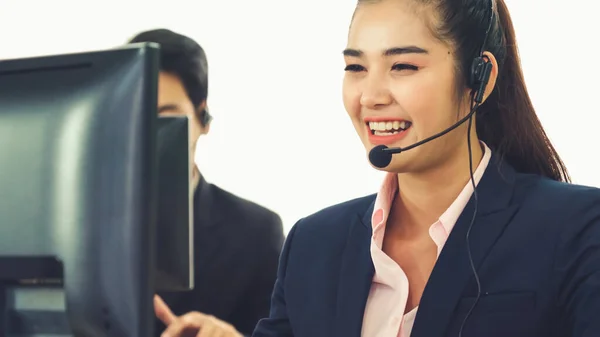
[{"x1": 333, "y1": 200, "x2": 375, "y2": 337}]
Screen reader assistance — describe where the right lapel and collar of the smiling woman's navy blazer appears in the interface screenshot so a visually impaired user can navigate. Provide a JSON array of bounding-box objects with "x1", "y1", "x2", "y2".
[{"x1": 411, "y1": 156, "x2": 517, "y2": 337}]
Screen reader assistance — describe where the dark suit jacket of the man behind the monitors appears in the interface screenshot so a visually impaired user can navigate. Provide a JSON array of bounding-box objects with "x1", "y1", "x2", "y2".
[{"x1": 155, "y1": 177, "x2": 285, "y2": 336}]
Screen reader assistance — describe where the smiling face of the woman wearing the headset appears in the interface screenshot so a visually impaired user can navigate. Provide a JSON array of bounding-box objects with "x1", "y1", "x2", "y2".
[{"x1": 343, "y1": 0, "x2": 469, "y2": 173}]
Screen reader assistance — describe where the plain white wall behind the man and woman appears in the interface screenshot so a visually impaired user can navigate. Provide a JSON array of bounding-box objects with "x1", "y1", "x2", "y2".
[{"x1": 0, "y1": 0, "x2": 600, "y2": 230}]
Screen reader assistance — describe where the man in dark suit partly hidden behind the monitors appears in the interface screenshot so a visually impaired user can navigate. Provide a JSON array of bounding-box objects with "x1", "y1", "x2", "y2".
[{"x1": 130, "y1": 29, "x2": 284, "y2": 337}]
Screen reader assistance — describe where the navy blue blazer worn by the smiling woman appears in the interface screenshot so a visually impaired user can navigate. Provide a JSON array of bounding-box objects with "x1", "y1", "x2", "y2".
[{"x1": 253, "y1": 156, "x2": 600, "y2": 337}]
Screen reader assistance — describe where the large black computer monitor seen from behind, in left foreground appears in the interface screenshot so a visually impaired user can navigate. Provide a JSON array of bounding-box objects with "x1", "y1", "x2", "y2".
[{"x1": 0, "y1": 44, "x2": 189, "y2": 337}]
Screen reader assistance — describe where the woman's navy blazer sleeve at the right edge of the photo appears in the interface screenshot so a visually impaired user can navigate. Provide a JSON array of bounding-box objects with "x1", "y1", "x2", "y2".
[{"x1": 556, "y1": 190, "x2": 600, "y2": 337}]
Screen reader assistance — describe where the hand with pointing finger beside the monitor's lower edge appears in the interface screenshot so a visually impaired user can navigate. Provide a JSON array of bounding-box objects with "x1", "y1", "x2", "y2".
[{"x1": 154, "y1": 295, "x2": 243, "y2": 337}]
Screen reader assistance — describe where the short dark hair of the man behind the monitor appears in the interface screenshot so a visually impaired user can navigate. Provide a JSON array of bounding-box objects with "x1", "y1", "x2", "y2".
[{"x1": 129, "y1": 28, "x2": 212, "y2": 126}]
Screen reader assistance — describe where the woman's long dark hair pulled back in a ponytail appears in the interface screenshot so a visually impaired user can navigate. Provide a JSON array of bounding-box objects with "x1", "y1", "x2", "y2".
[{"x1": 358, "y1": 0, "x2": 570, "y2": 182}]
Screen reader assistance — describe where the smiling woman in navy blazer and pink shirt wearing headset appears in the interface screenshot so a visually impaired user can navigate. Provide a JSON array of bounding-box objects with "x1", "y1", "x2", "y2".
[{"x1": 156, "y1": 0, "x2": 600, "y2": 337}]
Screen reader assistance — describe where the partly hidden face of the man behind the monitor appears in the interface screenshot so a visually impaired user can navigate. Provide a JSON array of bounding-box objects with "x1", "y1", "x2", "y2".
[{"x1": 158, "y1": 72, "x2": 208, "y2": 172}]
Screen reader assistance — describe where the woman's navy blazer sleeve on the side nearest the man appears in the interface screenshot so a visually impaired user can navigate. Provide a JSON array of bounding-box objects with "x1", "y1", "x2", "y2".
[{"x1": 252, "y1": 219, "x2": 299, "y2": 337}]
